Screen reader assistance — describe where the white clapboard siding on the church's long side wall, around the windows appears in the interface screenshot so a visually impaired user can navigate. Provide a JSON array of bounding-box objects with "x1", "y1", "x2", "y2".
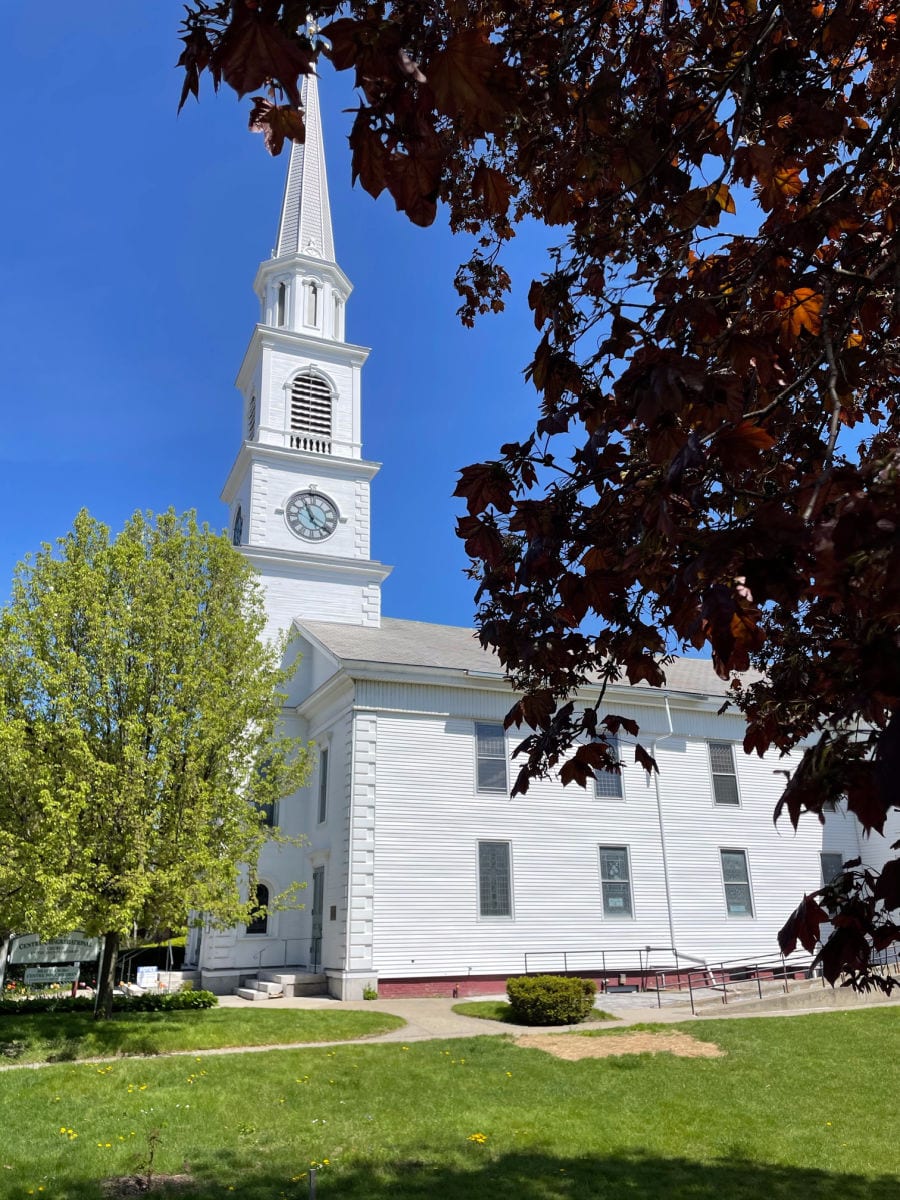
[{"x1": 370, "y1": 705, "x2": 821, "y2": 977}]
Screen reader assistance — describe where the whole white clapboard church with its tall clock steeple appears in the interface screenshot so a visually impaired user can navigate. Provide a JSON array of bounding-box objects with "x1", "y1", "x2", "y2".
[{"x1": 186, "y1": 77, "x2": 900, "y2": 1000}]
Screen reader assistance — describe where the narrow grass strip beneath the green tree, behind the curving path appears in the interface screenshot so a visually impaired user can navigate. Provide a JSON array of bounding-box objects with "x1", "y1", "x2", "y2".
[{"x1": 0, "y1": 1008, "x2": 404, "y2": 1065}]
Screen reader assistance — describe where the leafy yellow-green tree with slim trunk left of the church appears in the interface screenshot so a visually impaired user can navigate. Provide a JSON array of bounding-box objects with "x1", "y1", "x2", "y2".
[{"x1": 0, "y1": 511, "x2": 308, "y2": 1014}]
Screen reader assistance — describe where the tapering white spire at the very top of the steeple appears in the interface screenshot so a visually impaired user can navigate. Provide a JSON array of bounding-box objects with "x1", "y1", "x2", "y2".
[{"x1": 275, "y1": 74, "x2": 335, "y2": 263}]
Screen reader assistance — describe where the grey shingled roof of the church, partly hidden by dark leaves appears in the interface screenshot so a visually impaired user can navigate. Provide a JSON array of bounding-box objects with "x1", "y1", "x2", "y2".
[{"x1": 298, "y1": 617, "x2": 758, "y2": 696}]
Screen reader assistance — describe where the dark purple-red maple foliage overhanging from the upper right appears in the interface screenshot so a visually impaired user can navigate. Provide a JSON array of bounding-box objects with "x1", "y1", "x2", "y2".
[{"x1": 181, "y1": 0, "x2": 900, "y2": 986}]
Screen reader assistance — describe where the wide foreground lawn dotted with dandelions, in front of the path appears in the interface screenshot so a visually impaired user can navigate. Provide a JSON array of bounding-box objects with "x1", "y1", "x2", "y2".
[{"x1": 0, "y1": 1008, "x2": 900, "y2": 1200}]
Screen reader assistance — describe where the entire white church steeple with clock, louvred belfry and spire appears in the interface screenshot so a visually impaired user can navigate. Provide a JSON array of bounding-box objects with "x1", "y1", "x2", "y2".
[{"x1": 222, "y1": 68, "x2": 390, "y2": 634}]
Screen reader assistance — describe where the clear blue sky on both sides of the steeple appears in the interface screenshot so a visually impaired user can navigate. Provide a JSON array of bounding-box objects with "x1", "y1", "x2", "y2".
[{"x1": 0, "y1": 0, "x2": 542, "y2": 624}]
